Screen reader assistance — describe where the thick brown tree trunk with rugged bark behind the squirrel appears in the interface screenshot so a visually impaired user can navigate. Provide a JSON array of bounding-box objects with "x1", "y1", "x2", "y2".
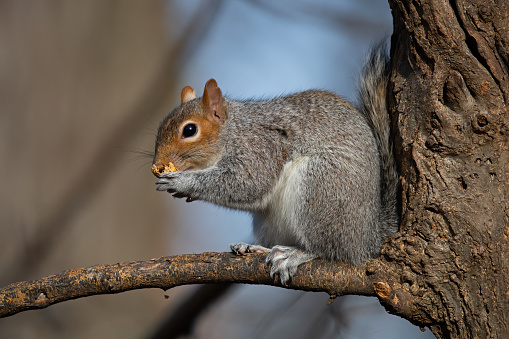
[{"x1": 377, "y1": 0, "x2": 509, "y2": 338}]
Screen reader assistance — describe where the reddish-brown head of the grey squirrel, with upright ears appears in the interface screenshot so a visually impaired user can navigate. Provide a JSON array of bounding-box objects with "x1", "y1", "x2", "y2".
[{"x1": 152, "y1": 79, "x2": 228, "y2": 176}]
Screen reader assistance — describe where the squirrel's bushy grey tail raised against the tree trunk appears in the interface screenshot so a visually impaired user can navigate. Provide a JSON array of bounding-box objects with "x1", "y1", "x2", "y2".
[{"x1": 357, "y1": 41, "x2": 399, "y2": 238}]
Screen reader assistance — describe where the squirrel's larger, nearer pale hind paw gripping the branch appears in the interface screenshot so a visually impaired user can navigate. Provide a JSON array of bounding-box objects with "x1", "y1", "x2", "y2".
[{"x1": 265, "y1": 246, "x2": 316, "y2": 286}]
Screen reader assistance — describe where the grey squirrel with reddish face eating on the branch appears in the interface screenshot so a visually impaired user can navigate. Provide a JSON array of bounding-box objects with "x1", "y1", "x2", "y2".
[{"x1": 152, "y1": 43, "x2": 399, "y2": 285}]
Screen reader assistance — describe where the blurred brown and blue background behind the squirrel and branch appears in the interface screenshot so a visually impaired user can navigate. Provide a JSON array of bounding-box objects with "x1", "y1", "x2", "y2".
[{"x1": 0, "y1": 0, "x2": 432, "y2": 338}]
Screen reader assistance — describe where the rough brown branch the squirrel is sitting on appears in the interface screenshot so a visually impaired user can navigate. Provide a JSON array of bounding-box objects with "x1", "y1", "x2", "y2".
[{"x1": 0, "y1": 253, "x2": 379, "y2": 317}]
